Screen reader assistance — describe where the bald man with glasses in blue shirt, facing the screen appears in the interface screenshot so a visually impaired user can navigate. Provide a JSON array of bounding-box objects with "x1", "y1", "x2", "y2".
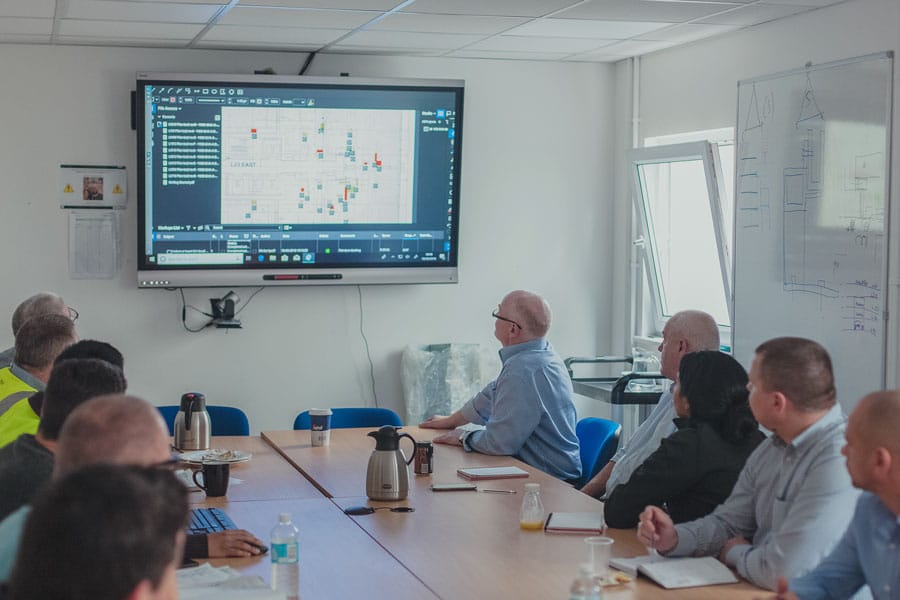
[{"x1": 421, "y1": 290, "x2": 581, "y2": 481}]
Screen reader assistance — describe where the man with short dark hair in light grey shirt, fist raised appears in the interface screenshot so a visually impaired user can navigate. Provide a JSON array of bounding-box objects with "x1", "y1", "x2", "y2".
[{"x1": 638, "y1": 337, "x2": 859, "y2": 589}]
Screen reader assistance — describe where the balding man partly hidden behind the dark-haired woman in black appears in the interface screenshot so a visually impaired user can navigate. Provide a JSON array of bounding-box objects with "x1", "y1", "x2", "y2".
[{"x1": 581, "y1": 310, "x2": 719, "y2": 498}]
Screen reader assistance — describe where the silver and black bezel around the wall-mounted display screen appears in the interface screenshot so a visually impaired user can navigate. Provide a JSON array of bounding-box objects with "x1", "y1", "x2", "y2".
[{"x1": 135, "y1": 72, "x2": 465, "y2": 288}]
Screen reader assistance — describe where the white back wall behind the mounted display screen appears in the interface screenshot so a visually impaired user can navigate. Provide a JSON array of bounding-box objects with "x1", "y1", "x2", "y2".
[{"x1": 0, "y1": 45, "x2": 615, "y2": 431}]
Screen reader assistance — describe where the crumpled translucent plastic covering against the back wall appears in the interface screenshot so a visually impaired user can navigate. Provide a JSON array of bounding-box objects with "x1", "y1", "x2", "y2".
[{"x1": 400, "y1": 344, "x2": 501, "y2": 425}]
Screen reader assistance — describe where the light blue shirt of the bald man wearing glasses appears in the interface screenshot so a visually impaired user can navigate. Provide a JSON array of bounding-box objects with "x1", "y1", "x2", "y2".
[{"x1": 460, "y1": 338, "x2": 581, "y2": 480}]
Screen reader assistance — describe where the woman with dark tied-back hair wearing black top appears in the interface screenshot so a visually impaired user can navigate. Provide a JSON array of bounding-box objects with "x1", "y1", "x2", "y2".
[{"x1": 604, "y1": 350, "x2": 765, "y2": 529}]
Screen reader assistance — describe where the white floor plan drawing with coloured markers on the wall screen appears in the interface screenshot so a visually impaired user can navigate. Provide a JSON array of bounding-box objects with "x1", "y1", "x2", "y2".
[{"x1": 221, "y1": 106, "x2": 416, "y2": 224}]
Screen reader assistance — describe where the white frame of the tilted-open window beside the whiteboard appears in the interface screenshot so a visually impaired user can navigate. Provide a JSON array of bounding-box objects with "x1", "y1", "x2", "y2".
[{"x1": 627, "y1": 141, "x2": 732, "y2": 338}]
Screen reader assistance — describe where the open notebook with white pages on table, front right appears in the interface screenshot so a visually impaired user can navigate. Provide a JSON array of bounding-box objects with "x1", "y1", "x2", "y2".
[{"x1": 609, "y1": 555, "x2": 737, "y2": 589}]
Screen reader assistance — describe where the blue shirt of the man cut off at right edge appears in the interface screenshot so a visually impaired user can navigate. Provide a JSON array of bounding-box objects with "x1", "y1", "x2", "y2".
[{"x1": 791, "y1": 492, "x2": 888, "y2": 600}]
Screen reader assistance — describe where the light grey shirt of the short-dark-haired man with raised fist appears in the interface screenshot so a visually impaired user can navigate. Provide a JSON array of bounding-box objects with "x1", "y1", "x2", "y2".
[{"x1": 669, "y1": 405, "x2": 859, "y2": 589}]
